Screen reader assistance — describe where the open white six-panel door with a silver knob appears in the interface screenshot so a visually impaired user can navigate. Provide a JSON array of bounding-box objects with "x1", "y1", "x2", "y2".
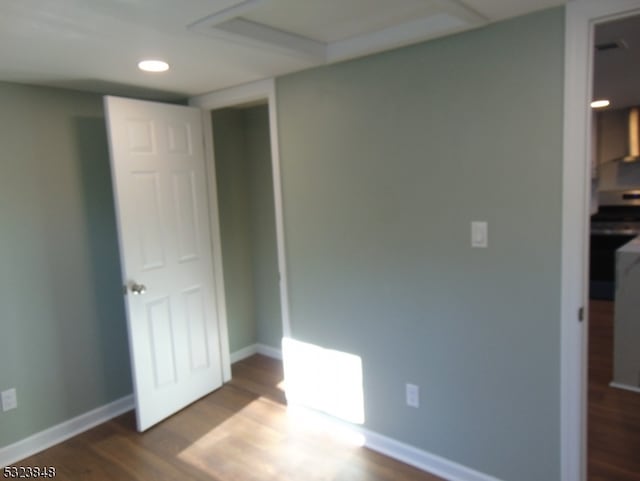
[{"x1": 105, "y1": 97, "x2": 222, "y2": 431}]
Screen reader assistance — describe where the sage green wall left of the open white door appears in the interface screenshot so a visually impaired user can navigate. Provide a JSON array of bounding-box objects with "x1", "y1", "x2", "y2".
[{"x1": 0, "y1": 83, "x2": 132, "y2": 447}]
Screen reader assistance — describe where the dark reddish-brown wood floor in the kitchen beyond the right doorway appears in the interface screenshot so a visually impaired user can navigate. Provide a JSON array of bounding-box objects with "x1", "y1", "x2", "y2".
[{"x1": 588, "y1": 301, "x2": 640, "y2": 481}]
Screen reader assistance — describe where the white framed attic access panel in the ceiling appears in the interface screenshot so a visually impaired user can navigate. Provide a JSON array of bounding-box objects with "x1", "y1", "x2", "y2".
[{"x1": 190, "y1": 0, "x2": 487, "y2": 63}]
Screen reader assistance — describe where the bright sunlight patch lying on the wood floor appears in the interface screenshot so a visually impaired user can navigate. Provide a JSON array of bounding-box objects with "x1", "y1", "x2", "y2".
[{"x1": 178, "y1": 397, "x2": 364, "y2": 481}]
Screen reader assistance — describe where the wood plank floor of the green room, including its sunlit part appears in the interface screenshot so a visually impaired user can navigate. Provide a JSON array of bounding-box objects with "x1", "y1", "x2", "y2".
[{"x1": 18, "y1": 355, "x2": 442, "y2": 481}]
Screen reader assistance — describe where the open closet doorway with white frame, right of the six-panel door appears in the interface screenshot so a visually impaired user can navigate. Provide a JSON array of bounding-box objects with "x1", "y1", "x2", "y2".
[{"x1": 189, "y1": 79, "x2": 291, "y2": 381}]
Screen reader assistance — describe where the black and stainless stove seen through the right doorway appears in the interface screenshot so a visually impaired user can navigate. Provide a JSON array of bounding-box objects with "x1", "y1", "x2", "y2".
[{"x1": 589, "y1": 190, "x2": 640, "y2": 300}]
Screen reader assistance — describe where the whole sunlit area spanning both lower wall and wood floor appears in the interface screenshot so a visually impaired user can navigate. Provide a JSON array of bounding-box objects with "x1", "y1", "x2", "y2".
[{"x1": 178, "y1": 338, "x2": 365, "y2": 481}]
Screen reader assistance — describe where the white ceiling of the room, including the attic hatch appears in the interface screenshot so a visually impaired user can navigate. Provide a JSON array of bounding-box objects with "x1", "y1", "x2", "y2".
[{"x1": 0, "y1": 0, "x2": 565, "y2": 99}]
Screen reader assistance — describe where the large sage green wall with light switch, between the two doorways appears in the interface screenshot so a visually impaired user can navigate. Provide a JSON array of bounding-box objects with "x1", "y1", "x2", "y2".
[{"x1": 277, "y1": 9, "x2": 564, "y2": 481}]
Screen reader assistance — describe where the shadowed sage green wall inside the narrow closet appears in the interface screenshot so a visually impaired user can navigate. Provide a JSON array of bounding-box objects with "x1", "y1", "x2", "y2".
[{"x1": 212, "y1": 106, "x2": 282, "y2": 352}]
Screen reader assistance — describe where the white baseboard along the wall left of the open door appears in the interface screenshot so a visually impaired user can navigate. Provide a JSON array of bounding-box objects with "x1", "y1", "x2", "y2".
[{"x1": 0, "y1": 395, "x2": 135, "y2": 467}]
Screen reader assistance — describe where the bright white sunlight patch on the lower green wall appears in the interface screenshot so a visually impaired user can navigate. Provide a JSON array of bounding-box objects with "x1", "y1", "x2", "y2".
[{"x1": 282, "y1": 338, "x2": 365, "y2": 424}]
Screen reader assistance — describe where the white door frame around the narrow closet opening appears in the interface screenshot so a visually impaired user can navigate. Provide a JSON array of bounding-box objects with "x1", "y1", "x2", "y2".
[{"x1": 189, "y1": 79, "x2": 291, "y2": 381}]
